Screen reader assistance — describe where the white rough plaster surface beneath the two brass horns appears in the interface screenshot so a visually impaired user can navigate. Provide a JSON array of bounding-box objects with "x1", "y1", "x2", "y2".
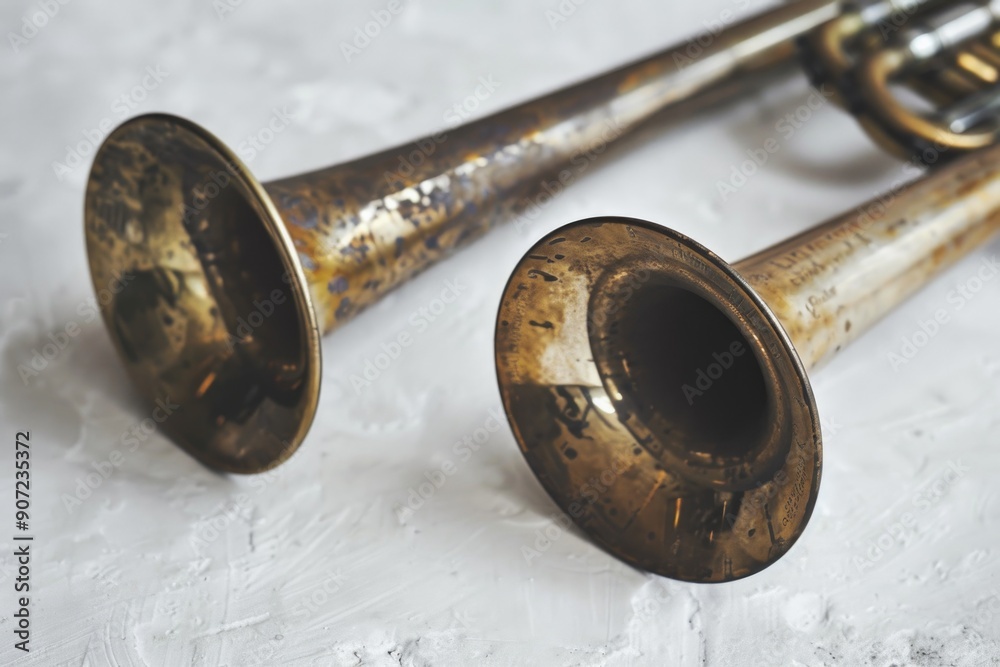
[{"x1": 0, "y1": 0, "x2": 1000, "y2": 665}]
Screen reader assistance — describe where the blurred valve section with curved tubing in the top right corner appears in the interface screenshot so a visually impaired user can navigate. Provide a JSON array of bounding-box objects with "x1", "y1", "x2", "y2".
[{"x1": 802, "y1": 0, "x2": 1000, "y2": 164}]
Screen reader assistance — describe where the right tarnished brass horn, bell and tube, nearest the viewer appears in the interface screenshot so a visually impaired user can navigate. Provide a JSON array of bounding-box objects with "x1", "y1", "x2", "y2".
[{"x1": 496, "y1": 147, "x2": 1000, "y2": 582}]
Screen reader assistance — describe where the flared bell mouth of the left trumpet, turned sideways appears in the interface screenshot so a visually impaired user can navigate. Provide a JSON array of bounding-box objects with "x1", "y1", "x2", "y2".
[{"x1": 84, "y1": 114, "x2": 321, "y2": 473}]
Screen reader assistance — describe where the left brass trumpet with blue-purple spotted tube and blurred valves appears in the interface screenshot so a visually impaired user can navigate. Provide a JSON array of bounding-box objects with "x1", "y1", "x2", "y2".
[{"x1": 84, "y1": 0, "x2": 995, "y2": 473}]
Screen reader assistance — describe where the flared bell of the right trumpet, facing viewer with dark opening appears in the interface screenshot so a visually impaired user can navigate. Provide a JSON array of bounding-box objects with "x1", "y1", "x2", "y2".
[{"x1": 496, "y1": 218, "x2": 822, "y2": 583}]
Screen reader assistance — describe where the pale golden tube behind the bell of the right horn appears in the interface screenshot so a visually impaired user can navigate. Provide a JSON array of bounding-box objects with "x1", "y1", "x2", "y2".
[{"x1": 733, "y1": 149, "x2": 1000, "y2": 370}]
